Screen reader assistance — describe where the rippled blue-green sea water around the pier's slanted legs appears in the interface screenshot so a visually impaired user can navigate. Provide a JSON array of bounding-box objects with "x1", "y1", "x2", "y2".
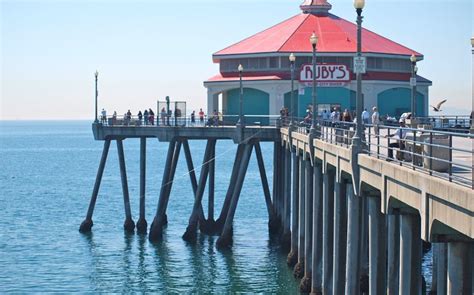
[{"x1": 0, "y1": 121, "x2": 298, "y2": 293}]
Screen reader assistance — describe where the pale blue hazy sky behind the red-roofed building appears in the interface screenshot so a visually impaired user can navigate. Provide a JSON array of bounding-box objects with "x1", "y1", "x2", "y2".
[{"x1": 0, "y1": 0, "x2": 474, "y2": 119}]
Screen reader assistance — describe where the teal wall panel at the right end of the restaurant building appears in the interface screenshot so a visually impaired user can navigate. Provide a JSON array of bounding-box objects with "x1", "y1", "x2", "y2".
[{"x1": 377, "y1": 87, "x2": 426, "y2": 117}]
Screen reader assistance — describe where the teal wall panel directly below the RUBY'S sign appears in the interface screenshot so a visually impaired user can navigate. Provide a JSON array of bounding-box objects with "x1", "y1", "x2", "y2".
[{"x1": 284, "y1": 87, "x2": 356, "y2": 117}]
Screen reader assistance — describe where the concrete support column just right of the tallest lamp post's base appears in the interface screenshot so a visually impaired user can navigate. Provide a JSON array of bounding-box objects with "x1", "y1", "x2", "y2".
[{"x1": 366, "y1": 196, "x2": 387, "y2": 294}]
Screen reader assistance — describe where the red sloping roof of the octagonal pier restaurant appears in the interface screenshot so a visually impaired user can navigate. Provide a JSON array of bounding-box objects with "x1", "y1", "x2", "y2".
[{"x1": 214, "y1": 13, "x2": 422, "y2": 57}]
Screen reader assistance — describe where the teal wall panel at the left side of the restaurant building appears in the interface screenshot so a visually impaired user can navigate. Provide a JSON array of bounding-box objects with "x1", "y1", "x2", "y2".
[{"x1": 223, "y1": 88, "x2": 270, "y2": 124}]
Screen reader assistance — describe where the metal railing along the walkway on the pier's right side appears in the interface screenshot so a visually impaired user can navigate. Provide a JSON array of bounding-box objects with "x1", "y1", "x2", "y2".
[{"x1": 295, "y1": 118, "x2": 474, "y2": 189}]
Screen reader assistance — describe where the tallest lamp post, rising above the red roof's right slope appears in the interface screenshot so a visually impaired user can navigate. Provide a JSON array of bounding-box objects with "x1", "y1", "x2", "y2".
[{"x1": 352, "y1": 0, "x2": 365, "y2": 148}]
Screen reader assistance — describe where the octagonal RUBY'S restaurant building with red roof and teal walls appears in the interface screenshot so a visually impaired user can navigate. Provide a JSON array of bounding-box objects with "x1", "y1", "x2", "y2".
[{"x1": 204, "y1": 0, "x2": 431, "y2": 117}]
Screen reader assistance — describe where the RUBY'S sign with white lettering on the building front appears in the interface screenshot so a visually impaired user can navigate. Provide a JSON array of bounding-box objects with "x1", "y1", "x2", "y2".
[{"x1": 300, "y1": 64, "x2": 351, "y2": 83}]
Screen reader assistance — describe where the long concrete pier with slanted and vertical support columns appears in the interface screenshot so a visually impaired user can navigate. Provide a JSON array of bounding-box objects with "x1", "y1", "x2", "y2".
[{"x1": 80, "y1": 118, "x2": 474, "y2": 294}]
